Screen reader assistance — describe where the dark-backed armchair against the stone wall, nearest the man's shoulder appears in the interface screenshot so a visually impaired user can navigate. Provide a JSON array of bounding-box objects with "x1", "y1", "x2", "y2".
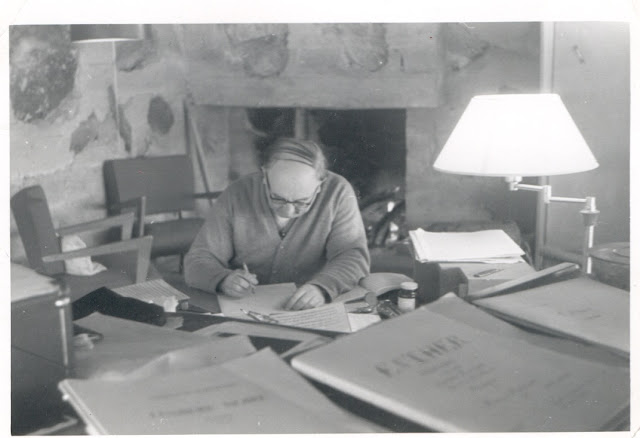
[{"x1": 103, "y1": 155, "x2": 220, "y2": 266}]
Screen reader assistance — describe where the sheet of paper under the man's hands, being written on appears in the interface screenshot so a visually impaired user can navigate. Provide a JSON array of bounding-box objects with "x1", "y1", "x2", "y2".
[{"x1": 218, "y1": 283, "x2": 296, "y2": 319}]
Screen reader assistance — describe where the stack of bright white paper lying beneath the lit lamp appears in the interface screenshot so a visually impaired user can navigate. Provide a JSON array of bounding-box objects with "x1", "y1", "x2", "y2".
[{"x1": 409, "y1": 228, "x2": 524, "y2": 263}]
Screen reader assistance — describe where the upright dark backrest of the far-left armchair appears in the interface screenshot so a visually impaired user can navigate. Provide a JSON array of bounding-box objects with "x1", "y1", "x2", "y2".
[{"x1": 11, "y1": 186, "x2": 64, "y2": 275}]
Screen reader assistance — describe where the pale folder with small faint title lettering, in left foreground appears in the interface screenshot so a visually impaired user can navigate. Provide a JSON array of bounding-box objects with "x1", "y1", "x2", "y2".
[{"x1": 59, "y1": 354, "x2": 375, "y2": 435}]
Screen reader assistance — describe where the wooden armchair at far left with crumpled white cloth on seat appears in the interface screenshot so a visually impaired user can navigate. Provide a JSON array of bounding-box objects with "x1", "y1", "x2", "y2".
[{"x1": 11, "y1": 185, "x2": 153, "y2": 300}]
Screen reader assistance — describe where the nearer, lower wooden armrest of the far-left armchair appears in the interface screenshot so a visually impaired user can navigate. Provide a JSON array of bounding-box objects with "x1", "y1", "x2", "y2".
[{"x1": 42, "y1": 236, "x2": 153, "y2": 283}]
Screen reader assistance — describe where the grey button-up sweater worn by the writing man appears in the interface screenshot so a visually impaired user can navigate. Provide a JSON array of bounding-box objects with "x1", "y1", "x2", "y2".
[{"x1": 185, "y1": 172, "x2": 370, "y2": 298}]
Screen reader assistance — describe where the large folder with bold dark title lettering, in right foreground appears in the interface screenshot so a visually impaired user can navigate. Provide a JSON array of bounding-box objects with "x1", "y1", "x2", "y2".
[{"x1": 291, "y1": 299, "x2": 630, "y2": 432}]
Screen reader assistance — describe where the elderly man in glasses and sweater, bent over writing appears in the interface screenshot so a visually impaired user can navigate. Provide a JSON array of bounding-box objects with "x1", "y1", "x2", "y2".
[{"x1": 185, "y1": 138, "x2": 370, "y2": 310}]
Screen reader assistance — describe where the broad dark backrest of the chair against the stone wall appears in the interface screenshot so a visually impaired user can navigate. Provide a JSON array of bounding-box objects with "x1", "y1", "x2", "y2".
[{"x1": 103, "y1": 155, "x2": 196, "y2": 214}]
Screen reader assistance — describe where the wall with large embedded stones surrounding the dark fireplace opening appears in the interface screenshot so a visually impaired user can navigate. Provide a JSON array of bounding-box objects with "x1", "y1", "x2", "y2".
[{"x1": 10, "y1": 23, "x2": 538, "y2": 259}]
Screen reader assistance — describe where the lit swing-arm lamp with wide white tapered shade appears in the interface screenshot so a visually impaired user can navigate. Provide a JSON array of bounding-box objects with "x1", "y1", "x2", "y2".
[{"x1": 433, "y1": 94, "x2": 599, "y2": 273}]
